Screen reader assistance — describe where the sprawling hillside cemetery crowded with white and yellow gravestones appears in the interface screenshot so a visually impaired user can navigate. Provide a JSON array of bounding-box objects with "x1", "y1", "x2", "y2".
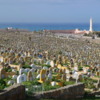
[{"x1": 0, "y1": 32, "x2": 100, "y2": 99}]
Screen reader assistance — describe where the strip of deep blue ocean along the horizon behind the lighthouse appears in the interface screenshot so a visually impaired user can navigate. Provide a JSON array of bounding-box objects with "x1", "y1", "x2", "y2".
[{"x1": 0, "y1": 23, "x2": 100, "y2": 31}]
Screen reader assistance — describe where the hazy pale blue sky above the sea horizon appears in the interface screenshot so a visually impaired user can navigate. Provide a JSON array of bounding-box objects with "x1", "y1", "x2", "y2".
[{"x1": 0, "y1": 0, "x2": 100, "y2": 23}]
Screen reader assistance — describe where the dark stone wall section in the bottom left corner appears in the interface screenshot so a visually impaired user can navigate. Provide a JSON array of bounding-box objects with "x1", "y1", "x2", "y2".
[{"x1": 0, "y1": 84, "x2": 25, "y2": 100}]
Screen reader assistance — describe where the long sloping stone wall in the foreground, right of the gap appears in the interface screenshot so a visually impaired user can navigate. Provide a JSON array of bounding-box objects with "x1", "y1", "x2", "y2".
[{"x1": 35, "y1": 83, "x2": 85, "y2": 100}]
